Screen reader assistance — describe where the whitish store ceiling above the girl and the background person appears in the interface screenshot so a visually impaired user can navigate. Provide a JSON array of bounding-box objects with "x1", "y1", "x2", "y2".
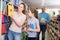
[{"x1": 23, "y1": 0, "x2": 60, "y2": 8}]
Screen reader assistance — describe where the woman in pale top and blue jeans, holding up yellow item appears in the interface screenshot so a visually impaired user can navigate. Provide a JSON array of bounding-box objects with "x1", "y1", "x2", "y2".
[{"x1": 8, "y1": 3, "x2": 26, "y2": 40}]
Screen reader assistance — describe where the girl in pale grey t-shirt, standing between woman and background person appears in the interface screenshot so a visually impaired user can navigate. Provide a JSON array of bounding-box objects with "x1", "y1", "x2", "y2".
[{"x1": 24, "y1": 10, "x2": 40, "y2": 40}]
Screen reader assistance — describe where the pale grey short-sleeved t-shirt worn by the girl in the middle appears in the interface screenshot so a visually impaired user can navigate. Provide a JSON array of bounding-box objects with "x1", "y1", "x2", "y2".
[{"x1": 27, "y1": 18, "x2": 39, "y2": 37}]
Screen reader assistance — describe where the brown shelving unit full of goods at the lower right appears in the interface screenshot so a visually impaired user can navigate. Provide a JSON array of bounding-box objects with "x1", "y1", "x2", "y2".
[{"x1": 47, "y1": 20, "x2": 60, "y2": 40}]
